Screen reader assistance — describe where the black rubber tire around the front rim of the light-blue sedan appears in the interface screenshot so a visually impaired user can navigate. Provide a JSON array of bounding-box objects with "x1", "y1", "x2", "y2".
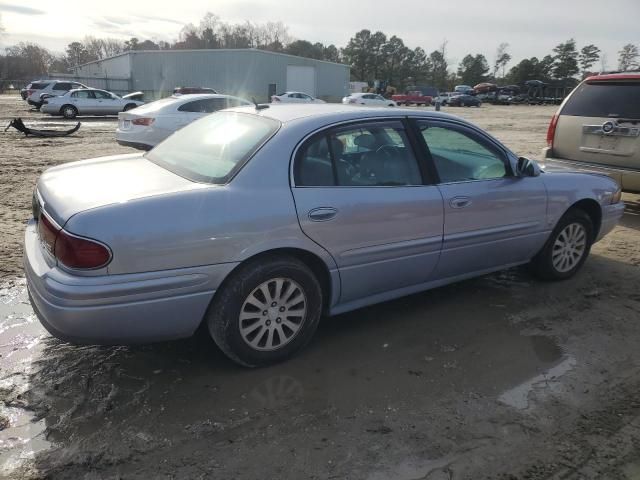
[{"x1": 530, "y1": 208, "x2": 594, "y2": 280}]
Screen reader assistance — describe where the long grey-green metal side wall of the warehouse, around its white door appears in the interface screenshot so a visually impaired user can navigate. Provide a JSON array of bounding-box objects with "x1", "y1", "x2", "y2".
[{"x1": 126, "y1": 50, "x2": 349, "y2": 102}]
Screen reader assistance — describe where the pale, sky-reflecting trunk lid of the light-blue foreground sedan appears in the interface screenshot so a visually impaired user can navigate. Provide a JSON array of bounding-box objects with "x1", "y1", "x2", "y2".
[{"x1": 37, "y1": 153, "x2": 204, "y2": 226}]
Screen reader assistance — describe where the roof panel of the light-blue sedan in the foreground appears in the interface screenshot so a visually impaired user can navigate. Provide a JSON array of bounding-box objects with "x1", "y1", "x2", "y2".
[{"x1": 227, "y1": 103, "x2": 469, "y2": 124}]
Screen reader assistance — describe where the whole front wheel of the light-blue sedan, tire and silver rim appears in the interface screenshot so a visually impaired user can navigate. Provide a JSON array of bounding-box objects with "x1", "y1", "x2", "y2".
[{"x1": 531, "y1": 209, "x2": 594, "y2": 280}]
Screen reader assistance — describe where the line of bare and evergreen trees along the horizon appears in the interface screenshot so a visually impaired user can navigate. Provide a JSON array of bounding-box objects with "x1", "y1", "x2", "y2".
[{"x1": 0, "y1": 13, "x2": 640, "y2": 90}]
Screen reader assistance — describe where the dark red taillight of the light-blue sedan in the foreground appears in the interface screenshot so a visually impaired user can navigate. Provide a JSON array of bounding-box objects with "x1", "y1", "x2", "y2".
[{"x1": 38, "y1": 213, "x2": 111, "y2": 269}]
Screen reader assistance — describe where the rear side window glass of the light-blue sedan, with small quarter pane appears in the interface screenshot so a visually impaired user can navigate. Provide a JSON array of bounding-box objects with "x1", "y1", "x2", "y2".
[{"x1": 294, "y1": 122, "x2": 422, "y2": 187}]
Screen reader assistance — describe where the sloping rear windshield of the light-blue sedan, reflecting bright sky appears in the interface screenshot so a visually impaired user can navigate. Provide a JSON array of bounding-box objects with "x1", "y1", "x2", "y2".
[{"x1": 146, "y1": 112, "x2": 279, "y2": 184}]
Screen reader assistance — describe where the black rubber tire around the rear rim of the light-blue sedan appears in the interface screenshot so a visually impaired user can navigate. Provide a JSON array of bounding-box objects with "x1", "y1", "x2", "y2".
[{"x1": 205, "y1": 255, "x2": 322, "y2": 367}]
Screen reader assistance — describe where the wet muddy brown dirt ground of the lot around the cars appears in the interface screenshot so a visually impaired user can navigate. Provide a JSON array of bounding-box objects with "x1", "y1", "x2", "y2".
[{"x1": 0, "y1": 96, "x2": 640, "y2": 480}]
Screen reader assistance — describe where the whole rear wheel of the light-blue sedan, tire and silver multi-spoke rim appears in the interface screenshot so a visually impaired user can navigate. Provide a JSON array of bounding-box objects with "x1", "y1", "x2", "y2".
[{"x1": 206, "y1": 256, "x2": 322, "y2": 367}]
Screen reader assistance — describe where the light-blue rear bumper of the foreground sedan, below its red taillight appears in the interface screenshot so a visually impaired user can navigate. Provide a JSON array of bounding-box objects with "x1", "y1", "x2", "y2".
[{"x1": 24, "y1": 220, "x2": 235, "y2": 345}]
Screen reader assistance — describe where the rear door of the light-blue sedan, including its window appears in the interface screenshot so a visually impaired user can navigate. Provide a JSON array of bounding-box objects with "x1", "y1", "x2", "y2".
[{"x1": 292, "y1": 120, "x2": 443, "y2": 303}]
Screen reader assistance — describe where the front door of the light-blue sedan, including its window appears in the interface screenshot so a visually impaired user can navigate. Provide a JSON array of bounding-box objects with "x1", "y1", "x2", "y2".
[{"x1": 417, "y1": 120, "x2": 549, "y2": 278}]
